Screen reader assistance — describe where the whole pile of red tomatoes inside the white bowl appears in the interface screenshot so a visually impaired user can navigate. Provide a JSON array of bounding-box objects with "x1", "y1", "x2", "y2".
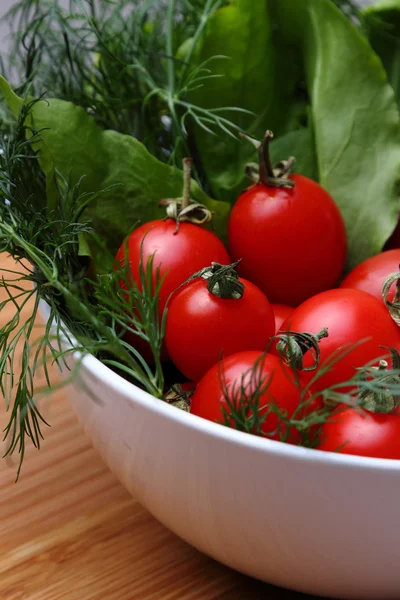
[{"x1": 118, "y1": 136, "x2": 400, "y2": 459}]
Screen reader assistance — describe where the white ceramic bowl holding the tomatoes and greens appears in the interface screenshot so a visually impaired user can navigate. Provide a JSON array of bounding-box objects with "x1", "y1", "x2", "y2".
[{"x1": 49, "y1": 311, "x2": 400, "y2": 600}]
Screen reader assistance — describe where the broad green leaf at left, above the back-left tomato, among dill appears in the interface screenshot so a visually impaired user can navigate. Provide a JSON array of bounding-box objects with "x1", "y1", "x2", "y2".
[{"x1": 0, "y1": 79, "x2": 229, "y2": 270}]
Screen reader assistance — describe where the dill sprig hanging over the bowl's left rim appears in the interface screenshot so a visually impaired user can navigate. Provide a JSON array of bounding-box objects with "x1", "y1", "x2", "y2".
[{"x1": 0, "y1": 101, "x2": 165, "y2": 474}]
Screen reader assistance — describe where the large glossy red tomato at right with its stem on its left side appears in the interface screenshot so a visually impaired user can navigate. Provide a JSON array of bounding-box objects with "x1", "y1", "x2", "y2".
[{"x1": 281, "y1": 289, "x2": 400, "y2": 390}]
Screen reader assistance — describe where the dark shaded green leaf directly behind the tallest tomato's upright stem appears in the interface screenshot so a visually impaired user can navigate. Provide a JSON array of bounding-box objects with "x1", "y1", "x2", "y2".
[{"x1": 191, "y1": 0, "x2": 299, "y2": 202}]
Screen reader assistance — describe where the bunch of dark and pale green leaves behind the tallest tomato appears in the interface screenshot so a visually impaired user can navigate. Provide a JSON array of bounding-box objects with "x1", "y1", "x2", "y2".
[{"x1": 186, "y1": 0, "x2": 400, "y2": 268}]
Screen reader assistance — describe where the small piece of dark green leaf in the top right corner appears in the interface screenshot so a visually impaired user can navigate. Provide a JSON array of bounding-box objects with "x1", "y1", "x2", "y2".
[{"x1": 363, "y1": 0, "x2": 400, "y2": 104}]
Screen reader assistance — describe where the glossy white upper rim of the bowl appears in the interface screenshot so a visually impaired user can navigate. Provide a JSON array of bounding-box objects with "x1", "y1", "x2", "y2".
[{"x1": 79, "y1": 351, "x2": 400, "y2": 472}]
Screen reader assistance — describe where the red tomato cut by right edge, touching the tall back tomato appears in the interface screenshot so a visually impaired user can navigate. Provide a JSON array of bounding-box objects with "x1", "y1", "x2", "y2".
[{"x1": 340, "y1": 249, "x2": 400, "y2": 301}]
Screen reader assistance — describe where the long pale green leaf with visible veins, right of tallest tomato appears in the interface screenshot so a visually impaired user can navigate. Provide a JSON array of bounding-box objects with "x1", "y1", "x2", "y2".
[{"x1": 269, "y1": 0, "x2": 400, "y2": 268}]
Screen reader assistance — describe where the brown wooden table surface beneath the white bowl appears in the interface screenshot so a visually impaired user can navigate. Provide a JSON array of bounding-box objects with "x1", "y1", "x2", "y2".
[{"x1": 0, "y1": 255, "x2": 318, "y2": 600}]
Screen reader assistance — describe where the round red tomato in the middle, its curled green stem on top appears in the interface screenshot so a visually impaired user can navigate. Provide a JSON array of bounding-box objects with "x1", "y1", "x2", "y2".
[{"x1": 165, "y1": 279, "x2": 275, "y2": 381}]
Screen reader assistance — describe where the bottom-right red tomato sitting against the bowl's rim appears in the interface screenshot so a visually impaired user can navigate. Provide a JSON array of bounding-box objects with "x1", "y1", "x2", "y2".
[{"x1": 318, "y1": 405, "x2": 400, "y2": 459}]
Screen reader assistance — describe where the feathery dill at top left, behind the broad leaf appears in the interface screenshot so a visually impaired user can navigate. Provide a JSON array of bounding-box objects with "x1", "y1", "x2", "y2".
[{"x1": 3, "y1": 0, "x2": 247, "y2": 166}]
